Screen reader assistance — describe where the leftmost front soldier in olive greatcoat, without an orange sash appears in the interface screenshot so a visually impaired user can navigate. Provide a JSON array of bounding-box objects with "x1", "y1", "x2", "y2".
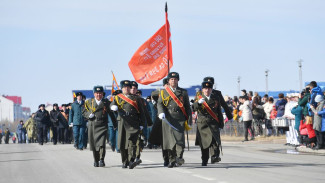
[{"x1": 83, "y1": 86, "x2": 117, "y2": 167}]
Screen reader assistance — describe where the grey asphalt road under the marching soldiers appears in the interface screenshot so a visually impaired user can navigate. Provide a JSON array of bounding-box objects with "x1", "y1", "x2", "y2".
[{"x1": 0, "y1": 142, "x2": 325, "y2": 183}]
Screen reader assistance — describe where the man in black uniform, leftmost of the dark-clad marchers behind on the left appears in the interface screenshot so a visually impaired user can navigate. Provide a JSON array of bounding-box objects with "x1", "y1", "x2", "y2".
[{"x1": 35, "y1": 104, "x2": 50, "y2": 145}]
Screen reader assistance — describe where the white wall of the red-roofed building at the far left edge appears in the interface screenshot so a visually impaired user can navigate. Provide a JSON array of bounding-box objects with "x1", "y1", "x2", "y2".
[{"x1": 0, "y1": 96, "x2": 15, "y2": 123}]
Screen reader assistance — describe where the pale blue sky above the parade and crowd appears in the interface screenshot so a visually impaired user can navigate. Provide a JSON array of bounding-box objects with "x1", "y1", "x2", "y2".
[{"x1": 0, "y1": 0, "x2": 325, "y2": 111}]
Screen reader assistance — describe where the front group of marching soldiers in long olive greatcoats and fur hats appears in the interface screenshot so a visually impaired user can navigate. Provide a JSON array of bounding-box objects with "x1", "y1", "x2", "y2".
[{"x1": 82, "y1": 72, "x2": 232, "y2": 169}]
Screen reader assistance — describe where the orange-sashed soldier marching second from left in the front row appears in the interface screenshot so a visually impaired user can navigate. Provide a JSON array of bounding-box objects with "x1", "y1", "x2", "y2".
[{"x1": 111, "y1": 80, "x2": 145, "y2": 169}]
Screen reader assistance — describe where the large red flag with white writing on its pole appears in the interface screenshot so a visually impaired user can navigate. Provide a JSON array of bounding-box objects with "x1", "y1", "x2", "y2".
[{"x1": 129, "y1": 3, "x2": 173, "y2": 85}]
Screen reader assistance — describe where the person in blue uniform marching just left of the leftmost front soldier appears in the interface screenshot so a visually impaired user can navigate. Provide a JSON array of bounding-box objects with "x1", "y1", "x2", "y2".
[{"x1": 69, "y1": 92, "x2": 86, "y2": 150}]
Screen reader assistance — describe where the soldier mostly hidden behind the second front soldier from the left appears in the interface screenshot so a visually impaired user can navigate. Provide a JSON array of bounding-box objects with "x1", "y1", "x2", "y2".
[{"x1": 130, "y1": 81, "x2": 152, "y2": 165}]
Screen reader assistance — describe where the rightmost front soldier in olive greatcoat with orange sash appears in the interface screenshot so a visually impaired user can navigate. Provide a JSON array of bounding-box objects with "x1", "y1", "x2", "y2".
[{"x1": 193, "y1": 82, "x2": 223, "y2": 166}]
